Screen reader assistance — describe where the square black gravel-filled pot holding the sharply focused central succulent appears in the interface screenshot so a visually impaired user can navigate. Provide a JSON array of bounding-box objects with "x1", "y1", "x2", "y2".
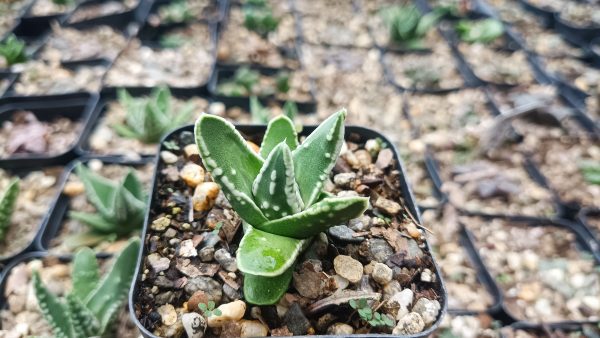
[{"x1": 129, "y1": 125, "x2": 447, "y2": 337}]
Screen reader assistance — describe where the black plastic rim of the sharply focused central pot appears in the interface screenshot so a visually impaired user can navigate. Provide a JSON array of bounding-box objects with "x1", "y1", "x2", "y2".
[{"x1": 129, "y1": 125, "x2": 447, "y2": 338}]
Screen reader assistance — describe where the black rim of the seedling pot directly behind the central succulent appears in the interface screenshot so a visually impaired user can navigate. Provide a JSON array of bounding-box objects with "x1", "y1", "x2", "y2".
[{"x1": 208, "y1": 67, "x2": 317, "y2": 113}]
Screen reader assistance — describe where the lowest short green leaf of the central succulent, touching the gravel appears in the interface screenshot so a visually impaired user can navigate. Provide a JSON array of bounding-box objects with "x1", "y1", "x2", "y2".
[{"x1": 244, "y1": 266, "x2": 294, "y2": 305}]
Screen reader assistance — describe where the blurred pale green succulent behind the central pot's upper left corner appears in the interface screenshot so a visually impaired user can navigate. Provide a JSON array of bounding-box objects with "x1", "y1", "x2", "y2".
[{"x1": 113, "y1": 87, "x2": 195, "y2": 143}]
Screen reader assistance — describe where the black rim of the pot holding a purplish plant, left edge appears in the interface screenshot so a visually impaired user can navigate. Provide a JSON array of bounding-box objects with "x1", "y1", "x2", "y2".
[{"x1": 0, "y1": 92, "x2": 98, "y2": 168}]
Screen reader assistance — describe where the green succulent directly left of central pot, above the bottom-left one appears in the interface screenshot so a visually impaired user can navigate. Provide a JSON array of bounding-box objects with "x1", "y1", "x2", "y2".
[{"x1": 69, "y1": 163, "x2": 146, "y2": 240}]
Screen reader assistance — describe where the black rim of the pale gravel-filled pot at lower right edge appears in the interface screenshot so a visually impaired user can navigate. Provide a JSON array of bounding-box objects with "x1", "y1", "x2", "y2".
[{"x1": 464, "y1": 216, "x2": 600, "y2": 328}]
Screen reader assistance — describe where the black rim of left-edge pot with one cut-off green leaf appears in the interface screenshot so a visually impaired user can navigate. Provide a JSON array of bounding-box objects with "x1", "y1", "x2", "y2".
[{"x1": 0, "y1": 166, "x2": 66, "y2": 266}]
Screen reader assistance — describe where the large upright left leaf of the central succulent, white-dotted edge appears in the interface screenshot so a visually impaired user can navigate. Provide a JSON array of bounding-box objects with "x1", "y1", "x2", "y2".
[{"x1": 194, "y1": 114, "x2": 267, "y2": 225}]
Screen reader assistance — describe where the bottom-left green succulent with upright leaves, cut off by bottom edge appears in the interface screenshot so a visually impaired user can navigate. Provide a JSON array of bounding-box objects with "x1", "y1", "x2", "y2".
[{"x1": 33, "y1": 238, "x2": 140, "y2": 338}]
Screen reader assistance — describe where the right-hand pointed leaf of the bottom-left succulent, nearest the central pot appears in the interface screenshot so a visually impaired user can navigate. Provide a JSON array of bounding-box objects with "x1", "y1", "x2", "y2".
[{"x1": 85, "y1": 238, "x2": 140, "y2": 332}]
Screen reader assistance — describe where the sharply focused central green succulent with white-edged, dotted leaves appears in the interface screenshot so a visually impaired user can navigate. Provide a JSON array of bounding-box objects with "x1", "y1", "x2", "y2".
[{"x1": 195, "y1": 110, "x2": 368, "y2": 305}]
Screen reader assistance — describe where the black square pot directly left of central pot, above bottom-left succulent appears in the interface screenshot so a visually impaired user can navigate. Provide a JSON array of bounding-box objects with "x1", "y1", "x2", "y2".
[{"x1": 35, "y1": 156, "x2": 151, "y2": 257}]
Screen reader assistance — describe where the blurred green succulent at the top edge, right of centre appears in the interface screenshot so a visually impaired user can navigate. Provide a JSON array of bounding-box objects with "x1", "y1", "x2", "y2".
[{"x1": 381, "y1": 5, "x2": 448, "y2": 49}]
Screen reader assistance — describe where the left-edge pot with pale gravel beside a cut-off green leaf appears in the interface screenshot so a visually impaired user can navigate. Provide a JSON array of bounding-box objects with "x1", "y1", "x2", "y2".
[{"x1": 0, "y1": 166, "x2": 66, "y2": 266}]
